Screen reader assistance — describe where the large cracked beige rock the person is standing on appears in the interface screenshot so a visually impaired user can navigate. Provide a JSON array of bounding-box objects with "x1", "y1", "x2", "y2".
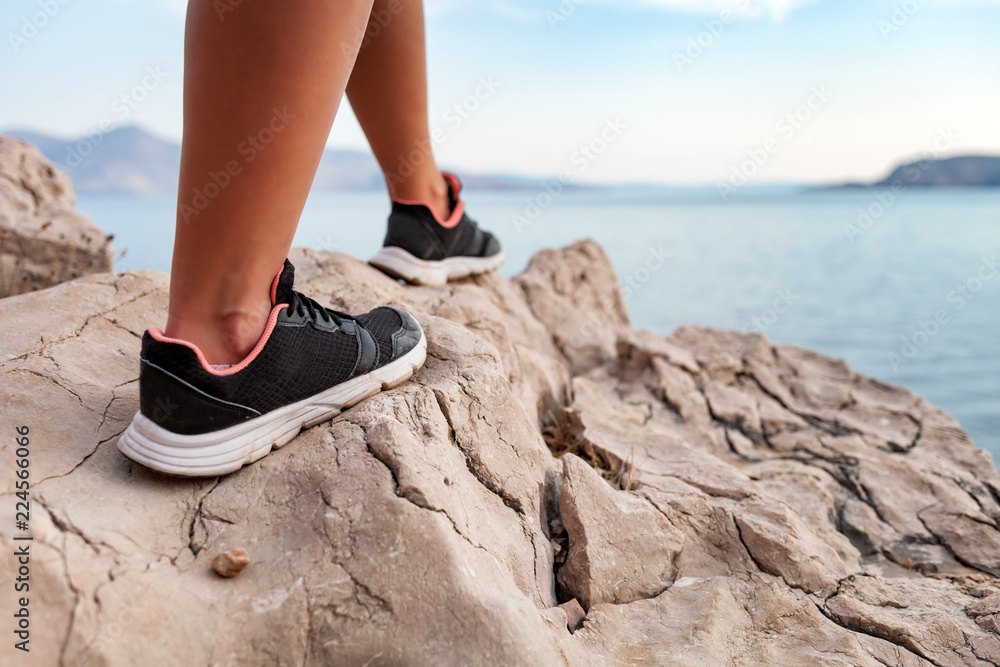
[{"x1": 0, "y1": 242, "x2": 1000, "y2": 666}]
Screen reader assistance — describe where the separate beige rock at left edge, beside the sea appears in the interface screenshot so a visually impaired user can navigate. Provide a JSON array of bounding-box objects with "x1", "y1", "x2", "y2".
[{"x1": 0, "y1": 135, "x2": 114, "y2": 297}]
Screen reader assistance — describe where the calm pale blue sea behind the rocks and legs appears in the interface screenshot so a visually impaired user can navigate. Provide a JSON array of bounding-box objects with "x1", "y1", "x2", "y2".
[{"x1": 78, "y1": 190, "x2": 1000, "y2": 458}]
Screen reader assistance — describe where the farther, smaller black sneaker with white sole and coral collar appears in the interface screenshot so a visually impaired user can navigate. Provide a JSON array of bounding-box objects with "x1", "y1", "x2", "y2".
[{"x1": 369, "y1": 172, "x2": 506, "y2": 285}]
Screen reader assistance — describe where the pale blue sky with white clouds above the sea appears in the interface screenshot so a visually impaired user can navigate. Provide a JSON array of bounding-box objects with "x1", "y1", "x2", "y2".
[{"x1": 0, "y1": 0, "x2": 1000, "y2": 185}]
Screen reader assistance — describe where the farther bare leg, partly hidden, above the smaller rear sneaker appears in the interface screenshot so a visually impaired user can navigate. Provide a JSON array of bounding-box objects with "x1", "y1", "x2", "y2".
[{"x1": 347, "y1": 0, "x2": 449, "y2": 219}]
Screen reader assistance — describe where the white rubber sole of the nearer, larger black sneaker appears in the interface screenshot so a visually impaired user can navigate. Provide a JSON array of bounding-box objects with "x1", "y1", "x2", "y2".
[{"x1": 118, "y1": 335, "x2": 427, "y2": 477}]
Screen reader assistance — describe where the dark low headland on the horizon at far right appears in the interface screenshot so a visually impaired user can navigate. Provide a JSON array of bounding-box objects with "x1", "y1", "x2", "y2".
[{"x1": 833, "y1": 155, "x2": 1000, "y2": 188}]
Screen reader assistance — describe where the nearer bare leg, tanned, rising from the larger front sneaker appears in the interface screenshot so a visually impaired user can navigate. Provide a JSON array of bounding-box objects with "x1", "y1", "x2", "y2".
[{"x1": 165, "y1": 0, "x2": 371, "y2": 364}]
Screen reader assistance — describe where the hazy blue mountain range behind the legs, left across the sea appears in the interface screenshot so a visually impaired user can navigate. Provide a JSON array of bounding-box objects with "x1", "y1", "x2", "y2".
[{"x1": 3, "y1": 126, "x2": 564, "y2": 196}]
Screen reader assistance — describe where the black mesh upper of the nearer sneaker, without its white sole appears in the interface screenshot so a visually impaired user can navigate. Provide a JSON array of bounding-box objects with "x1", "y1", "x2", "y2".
[{"x1": 140, "y1": 260, "x2": 421, "y2": 434}]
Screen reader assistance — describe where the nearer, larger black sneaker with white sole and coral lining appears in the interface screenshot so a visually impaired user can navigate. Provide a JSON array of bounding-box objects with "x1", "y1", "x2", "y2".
[{"x1": 118, "y1": 260, "x2": 427, "y2": 477}]
